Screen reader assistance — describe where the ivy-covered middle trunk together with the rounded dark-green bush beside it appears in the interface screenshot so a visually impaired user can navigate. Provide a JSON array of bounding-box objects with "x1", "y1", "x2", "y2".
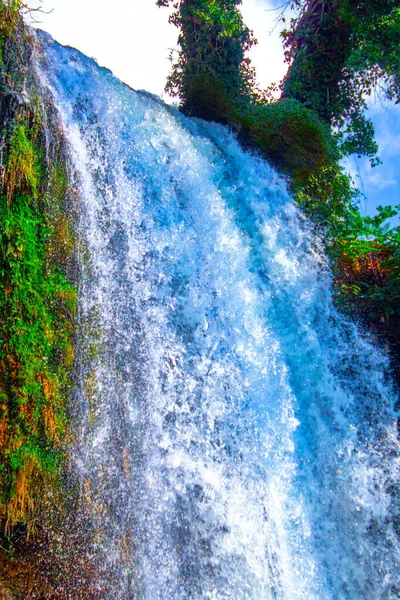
[{"x1": 158, "y1": 0, "x2": 335, "y2": 179}]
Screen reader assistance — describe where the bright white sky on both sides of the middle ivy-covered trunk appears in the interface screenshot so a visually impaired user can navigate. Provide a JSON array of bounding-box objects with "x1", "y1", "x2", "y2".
[{"x1": 31, "y1": 0, "x2": 286, "y2": 95}]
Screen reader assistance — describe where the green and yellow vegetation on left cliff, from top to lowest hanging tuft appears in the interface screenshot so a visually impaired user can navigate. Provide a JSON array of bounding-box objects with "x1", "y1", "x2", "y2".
[{"x1": 0, "y1": 2, "x2": 76, "y2": 531}]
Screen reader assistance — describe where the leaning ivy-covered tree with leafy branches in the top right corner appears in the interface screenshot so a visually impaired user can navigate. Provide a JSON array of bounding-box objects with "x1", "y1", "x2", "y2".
[{"x1": 282, "y1": 0, "x2": 400, "y2": 164}]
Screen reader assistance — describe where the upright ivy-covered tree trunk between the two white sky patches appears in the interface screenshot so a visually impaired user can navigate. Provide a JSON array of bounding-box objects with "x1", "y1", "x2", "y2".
[{"x1": 158, "y1": 0, "x2": 254, "y2": 123}]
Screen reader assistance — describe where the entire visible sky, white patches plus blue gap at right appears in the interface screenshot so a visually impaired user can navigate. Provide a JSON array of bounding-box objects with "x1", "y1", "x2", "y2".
[{"x1": 30, "y1": 0, "x2": 400, "y2": 223}]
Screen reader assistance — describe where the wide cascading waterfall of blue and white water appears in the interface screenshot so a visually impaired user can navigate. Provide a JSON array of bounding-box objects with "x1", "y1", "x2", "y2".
[{"x1": 35, "y1": 34, "x2": 400, "y2": 600}]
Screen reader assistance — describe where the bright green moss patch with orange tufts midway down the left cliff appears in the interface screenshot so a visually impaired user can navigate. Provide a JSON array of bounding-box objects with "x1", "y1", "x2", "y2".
[{"x1": 0, "y1": 173, "x2": 76, "y2": 521}]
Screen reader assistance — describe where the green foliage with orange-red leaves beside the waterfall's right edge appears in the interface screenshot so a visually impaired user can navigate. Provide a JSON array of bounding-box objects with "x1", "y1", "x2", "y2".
[{"x1": 293, "y1": 157, "x2": 400, "y2": 360}]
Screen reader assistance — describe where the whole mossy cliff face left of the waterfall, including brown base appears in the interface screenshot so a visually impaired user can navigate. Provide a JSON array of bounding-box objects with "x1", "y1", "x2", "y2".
[{"x1": 0, "y1": 12, "x2": 96, "y2": 600}]
